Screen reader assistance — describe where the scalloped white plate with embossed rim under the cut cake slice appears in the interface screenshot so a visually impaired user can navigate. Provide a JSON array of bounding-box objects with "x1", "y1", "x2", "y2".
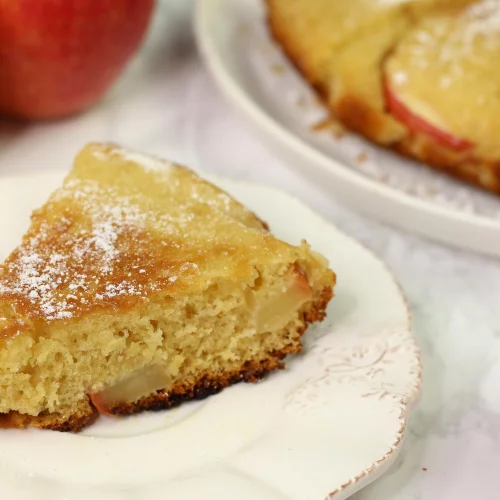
[{"x1": 0, "y1": 174, "x2": 421, "y2": 500}]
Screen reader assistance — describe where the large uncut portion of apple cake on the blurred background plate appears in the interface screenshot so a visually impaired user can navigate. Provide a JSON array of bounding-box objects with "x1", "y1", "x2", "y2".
[{"x1": 266, "y1": 0, "x2": 500, "y2": 194}]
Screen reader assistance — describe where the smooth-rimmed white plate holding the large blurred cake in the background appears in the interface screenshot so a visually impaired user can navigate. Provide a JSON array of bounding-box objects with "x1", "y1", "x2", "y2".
[{"x1": 196, "y1": 0, "x2": 500, "y2": 256}]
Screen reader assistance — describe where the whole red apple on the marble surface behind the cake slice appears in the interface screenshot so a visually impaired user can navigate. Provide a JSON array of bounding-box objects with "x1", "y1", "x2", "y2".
[{"x1": 0, "y1": 0, "x2": 155, "y2": 120}]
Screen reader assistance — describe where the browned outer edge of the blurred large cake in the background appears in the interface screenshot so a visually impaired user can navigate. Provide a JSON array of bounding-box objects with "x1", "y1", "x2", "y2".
[{"x1": 266, "y1": 0, "x2": 500, "y2": 195}]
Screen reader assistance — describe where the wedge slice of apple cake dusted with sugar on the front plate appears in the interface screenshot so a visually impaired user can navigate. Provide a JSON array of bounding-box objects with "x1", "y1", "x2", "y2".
[{"x1": 0, "y1": 144, "x2": 335, "y2": 431}]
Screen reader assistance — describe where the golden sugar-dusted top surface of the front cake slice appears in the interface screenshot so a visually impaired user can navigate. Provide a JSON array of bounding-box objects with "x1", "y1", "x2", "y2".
[{"x1": 0, "y1": 144, "x2": 308, "y2": 338}]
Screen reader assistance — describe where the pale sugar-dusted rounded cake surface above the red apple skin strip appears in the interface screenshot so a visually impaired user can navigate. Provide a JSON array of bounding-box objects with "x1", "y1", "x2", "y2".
[{"x1": 387, "y1": 0, "x2": 500, "y2": 158}]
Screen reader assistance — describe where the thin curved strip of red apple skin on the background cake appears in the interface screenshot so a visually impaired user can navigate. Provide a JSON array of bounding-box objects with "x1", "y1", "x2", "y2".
[{"x1": 384, "y1": 81, "x2": 474, "y2": 152}]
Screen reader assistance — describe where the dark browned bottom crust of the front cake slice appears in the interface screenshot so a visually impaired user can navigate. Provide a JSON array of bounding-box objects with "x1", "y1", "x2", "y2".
[{"x1": 0, "y1": 287, "x2": 333, "y2": 432}]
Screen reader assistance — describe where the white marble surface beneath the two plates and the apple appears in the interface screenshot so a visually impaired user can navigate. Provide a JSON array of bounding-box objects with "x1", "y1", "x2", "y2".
[{"x1": 0, "y1": 0, "x2": 500, "y2": 500}]
